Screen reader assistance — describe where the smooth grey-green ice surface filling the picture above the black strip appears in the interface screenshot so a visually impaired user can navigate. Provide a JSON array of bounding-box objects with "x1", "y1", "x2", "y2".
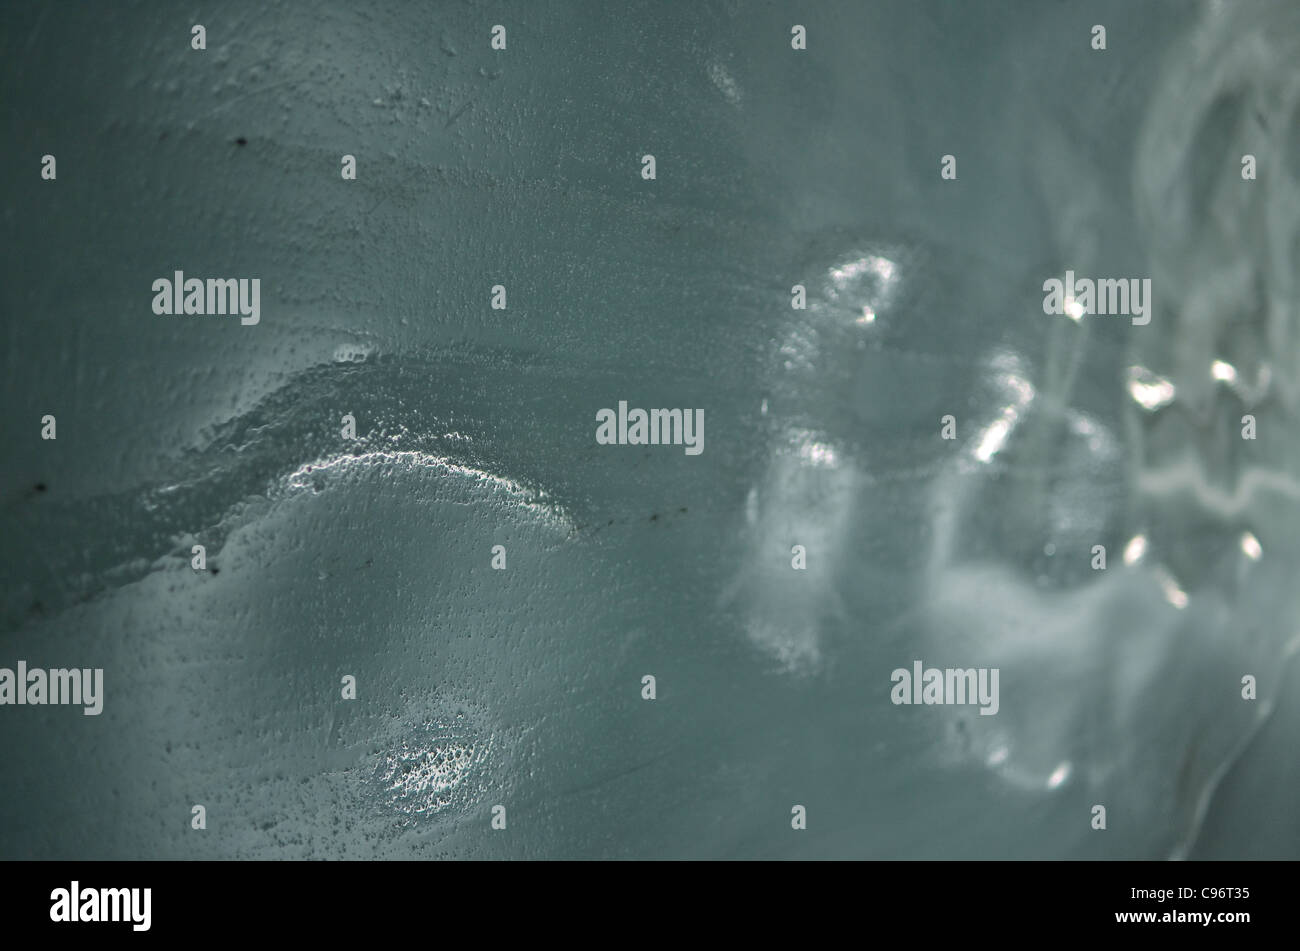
[{"x1": 0, "y1": 0, "x2": 1300, "y2": 859}]
